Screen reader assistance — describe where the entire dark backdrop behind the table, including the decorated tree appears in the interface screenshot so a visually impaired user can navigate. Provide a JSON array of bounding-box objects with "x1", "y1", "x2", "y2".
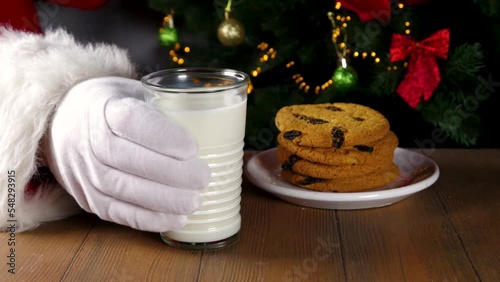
[{"x1": 36, "y1": 0, "x2": 500, "y2": 149}]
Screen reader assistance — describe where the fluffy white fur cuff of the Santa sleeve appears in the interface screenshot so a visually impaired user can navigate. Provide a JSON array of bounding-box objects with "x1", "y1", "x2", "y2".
[{"x1": 0, "y1": 28, "x2": 136, "y2": 232}]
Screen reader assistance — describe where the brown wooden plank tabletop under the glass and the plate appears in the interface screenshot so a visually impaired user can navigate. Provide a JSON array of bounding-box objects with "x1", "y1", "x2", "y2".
[{"x1": 0, "y1": 149, "x2": 500, "y2": 282}]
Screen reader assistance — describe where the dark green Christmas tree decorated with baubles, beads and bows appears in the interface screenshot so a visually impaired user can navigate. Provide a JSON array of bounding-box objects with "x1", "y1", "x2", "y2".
[{"x1": 149, "y1": 0, "x2": 500, "y2": 149}]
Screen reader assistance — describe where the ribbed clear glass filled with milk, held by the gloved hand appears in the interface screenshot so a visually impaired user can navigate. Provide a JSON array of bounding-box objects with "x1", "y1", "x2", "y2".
[{"x1": 141, "y1": 68, "x2": 249, "y2": 249}]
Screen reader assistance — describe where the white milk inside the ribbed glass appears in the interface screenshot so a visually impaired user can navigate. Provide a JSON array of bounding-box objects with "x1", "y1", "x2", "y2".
[{"x1": 150, "y1": 91, "x2": 247, "y2": 243}]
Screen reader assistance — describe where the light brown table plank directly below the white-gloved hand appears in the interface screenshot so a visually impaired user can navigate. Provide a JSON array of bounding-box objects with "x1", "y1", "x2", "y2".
[{"x1": 64, "y1": 218, "x2": 201, "y2": 282}]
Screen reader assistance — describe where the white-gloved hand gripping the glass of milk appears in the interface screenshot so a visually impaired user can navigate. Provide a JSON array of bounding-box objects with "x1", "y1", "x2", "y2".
[{"x1": 43, "y1": 77, "x2": 210, "y2": 232}]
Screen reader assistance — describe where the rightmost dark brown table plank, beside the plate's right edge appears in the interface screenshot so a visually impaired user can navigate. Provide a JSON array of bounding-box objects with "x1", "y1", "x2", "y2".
[{"x1": 431, "y1": 149, "x2": 500, "y2": 281}]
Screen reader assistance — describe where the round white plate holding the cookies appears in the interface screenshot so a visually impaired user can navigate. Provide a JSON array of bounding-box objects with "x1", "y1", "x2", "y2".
[{"x1": 245, "y1": 148, "x2": 439, "y2": 210}]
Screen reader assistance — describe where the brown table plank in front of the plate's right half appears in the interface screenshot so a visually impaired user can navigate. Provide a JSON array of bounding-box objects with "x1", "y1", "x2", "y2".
[{"x1": 338, "y1": 182, "x2": 476, "y2": 281}]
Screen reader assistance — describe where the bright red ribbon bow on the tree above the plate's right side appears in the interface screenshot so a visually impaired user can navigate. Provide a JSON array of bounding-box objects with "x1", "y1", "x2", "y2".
[{"x1": 390, "y1": 29, "x2": 450, "y2": 108}]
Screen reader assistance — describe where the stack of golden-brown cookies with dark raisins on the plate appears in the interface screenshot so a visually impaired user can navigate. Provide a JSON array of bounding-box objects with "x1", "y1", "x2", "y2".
[{"x1": 275, "y1": 103, "x2": 399, "y2": 192}]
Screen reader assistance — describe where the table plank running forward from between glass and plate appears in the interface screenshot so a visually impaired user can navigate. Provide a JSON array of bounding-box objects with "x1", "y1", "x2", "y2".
[{"x1": 199, "y1": 183, "x2": 344, "y2": 281}]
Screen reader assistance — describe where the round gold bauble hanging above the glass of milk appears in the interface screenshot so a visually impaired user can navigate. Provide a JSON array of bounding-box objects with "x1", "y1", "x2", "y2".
[{"x1": 217, "y1": 0, "x2": 245, "y2": 47}]
